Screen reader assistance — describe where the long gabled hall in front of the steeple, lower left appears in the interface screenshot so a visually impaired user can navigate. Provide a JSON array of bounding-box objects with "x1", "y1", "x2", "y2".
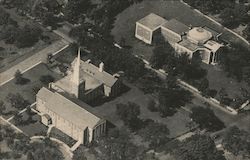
[{"x1": 36, "y1": 88, "x2": 106, "y2": 145}]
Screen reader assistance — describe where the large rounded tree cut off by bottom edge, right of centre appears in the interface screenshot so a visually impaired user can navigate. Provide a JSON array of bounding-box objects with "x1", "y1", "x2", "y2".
[{"x1": 172, "y1": 135, "x2": 226, "y2": 160}]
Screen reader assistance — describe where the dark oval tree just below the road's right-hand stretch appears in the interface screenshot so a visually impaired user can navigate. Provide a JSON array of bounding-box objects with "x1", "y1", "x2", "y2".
[{"x1": 190, "y1": 107, "x2": 225, "y2": 131}]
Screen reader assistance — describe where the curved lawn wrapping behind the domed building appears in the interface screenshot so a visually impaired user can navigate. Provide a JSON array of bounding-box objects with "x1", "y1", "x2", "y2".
[{"x1": 111, "y1": 0, "x2": 250, "y2": 60}]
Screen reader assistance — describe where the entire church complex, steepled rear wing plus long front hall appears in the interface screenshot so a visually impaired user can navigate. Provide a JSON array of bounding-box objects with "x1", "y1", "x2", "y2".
[{"x1": 36, "y1": 50, "x2": 121, "y2": 144}]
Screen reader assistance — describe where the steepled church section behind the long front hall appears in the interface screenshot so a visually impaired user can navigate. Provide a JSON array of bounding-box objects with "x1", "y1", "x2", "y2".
[{"x1": 50, "y1": 49, "x2": 122, "y2": 102}]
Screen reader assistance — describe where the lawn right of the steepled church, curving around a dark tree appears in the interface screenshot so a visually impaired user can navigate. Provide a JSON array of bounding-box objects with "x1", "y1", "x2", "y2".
[{"x1": 93, "y1": 84, "x2": 190, "y2": 137}]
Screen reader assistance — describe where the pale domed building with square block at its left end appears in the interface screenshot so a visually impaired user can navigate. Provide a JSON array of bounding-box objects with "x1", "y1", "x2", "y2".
[{"x1": 135, "y1": 13, "x2": 223, "y2": 64}]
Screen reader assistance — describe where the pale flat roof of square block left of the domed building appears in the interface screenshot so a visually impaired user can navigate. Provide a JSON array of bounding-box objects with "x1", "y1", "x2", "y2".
[{"x1": 137, "y1": 13, "x2": 167, "y2": 30}]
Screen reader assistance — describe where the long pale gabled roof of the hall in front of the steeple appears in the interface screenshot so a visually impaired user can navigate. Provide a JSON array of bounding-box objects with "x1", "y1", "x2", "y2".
[{"x1": 37, "y1": 87, "x2": 102, "y2": 129}]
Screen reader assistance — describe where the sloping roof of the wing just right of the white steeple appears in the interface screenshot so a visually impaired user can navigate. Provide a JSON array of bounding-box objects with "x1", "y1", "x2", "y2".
[{"x1": 80, "y1": 60, "x2": 118, "y2": 87}]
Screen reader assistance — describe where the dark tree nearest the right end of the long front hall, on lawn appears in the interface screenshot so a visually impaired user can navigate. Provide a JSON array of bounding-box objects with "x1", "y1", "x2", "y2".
[{"x1": 116, "y1": 102, "x2": 141, "y2": 130}]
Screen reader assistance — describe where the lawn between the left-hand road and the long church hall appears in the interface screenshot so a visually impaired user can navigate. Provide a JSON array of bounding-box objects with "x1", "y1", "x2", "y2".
[{"x1": 0, "y1": 64, "x2": 61, "y2": 118}]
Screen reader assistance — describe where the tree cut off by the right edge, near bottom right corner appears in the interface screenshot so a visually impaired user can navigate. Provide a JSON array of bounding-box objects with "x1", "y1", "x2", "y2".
[{"x1": 222, "y1": 126, "x2": 250, "y2": 157}]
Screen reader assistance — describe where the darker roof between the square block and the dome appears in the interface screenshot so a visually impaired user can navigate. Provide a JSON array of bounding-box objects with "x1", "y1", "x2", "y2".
[{"x1": 162, "y1": 19, "x2": 189, "y2": 35}]
